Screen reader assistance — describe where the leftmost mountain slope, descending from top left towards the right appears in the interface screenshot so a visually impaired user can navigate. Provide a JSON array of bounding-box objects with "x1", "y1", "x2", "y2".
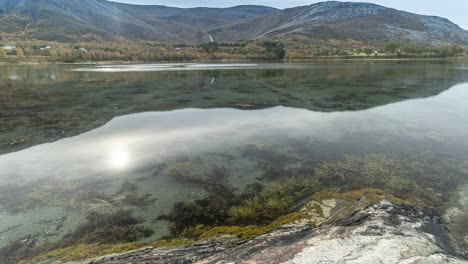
[{"x1": 0, "y1": 0, "x2": 177, "y2": 41}]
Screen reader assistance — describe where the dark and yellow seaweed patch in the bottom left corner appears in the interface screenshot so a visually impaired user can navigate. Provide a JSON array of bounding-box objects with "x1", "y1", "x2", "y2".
[{"x1": 7, "y1": 210, "x2": 153, "y2": 263}]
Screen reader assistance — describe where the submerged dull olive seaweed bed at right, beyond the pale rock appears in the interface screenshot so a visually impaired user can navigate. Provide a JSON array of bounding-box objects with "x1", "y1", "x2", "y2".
[{"x1": 314, "y1": 154, "x2": 466, "y2": 208}]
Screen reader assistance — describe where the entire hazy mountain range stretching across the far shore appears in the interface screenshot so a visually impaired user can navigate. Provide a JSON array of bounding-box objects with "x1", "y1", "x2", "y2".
[{"x1": 0, "y1": 0, "x2": 468, "y2": 45}]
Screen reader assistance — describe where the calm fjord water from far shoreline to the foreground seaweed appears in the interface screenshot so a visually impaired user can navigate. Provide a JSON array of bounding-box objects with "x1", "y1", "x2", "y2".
[{"x1": 0, "y1": 61, "x2": 468, "y2": 254}]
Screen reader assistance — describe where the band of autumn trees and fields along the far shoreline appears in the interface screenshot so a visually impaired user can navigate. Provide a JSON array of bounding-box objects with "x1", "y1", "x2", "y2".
[{"x1": 0, "y1": 38, "x2": 467, "y2": 62}]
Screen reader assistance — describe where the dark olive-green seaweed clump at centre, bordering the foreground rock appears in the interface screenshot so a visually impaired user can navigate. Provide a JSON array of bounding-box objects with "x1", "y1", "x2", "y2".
[{"x1": 158, "y1": 178, "x2": 319, "y2": 237}]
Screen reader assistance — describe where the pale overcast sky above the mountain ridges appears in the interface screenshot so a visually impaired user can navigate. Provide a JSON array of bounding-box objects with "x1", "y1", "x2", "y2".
[{"x1": 112, "y1": 0, "x2": 468, "y2": 29}]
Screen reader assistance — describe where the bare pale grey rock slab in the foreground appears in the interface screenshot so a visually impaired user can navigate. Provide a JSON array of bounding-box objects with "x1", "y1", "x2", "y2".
[{"x1": 66, "y1": 199, "x2": 468, "y2": 264}]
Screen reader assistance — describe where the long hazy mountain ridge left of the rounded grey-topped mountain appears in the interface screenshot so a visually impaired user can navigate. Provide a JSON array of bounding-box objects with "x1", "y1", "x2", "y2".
[{"x1": 0, "y1": 0, "x2": 276, "y2": 42}]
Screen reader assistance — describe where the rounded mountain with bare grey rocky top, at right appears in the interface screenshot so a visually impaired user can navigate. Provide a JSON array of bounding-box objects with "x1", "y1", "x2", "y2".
[{"x1": 211, "y1": 1, "x2": 468, "y2": 45}]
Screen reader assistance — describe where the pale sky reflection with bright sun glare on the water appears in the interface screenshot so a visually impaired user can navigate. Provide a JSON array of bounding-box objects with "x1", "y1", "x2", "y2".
[{"x1": 0, "y1": 84, "x2": 468, "y2": 186}]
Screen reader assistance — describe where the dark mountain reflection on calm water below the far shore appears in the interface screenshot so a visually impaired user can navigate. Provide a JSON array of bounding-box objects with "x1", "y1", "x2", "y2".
[{"x1": 0, "y1": 63, "x2": 468, "y2": 153}]
